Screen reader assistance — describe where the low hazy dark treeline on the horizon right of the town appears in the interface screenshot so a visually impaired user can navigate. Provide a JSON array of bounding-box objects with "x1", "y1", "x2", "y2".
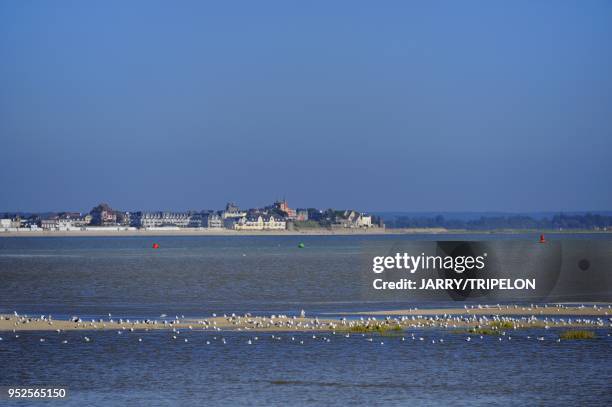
[{"x1": 386, "y1": 213, "x2": 612, "y2": 230}]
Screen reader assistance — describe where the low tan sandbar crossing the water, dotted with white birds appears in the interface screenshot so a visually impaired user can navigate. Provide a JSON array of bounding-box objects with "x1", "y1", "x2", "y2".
[{"x1": 0, "y1": 305, "x2": 612, "y2": 332}]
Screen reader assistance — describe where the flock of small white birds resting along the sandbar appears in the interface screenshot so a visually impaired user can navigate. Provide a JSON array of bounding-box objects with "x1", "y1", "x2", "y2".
[{"x1": 0, "y1": 305, "x2": 612, "y2": 345}]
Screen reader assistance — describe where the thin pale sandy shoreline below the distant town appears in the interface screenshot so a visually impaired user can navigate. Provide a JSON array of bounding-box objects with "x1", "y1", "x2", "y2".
[{"x1": 0, "y1": 228, "x2": 612, "y2": 238}]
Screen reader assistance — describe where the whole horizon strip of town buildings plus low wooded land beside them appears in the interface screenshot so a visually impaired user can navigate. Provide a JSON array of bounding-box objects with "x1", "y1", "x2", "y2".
[{"x1": 0, "y1": 199, "x2": 612, "y2": 235}]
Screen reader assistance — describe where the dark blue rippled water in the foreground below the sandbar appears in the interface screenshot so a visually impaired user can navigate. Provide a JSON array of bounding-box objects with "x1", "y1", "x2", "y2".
[{"x1": 0, "y1": 330, "x2": 612, "y2": 405}]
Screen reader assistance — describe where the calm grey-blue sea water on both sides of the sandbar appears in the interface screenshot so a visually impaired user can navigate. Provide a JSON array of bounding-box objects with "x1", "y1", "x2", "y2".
[{"x1": 0, "y1": 235, "x2": 612, "y2": 406}]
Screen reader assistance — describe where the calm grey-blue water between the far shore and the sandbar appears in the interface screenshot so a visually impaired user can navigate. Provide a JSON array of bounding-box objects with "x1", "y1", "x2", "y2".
[{"x1": 0, "y1": 234, "x2": 612, "y2": 317}]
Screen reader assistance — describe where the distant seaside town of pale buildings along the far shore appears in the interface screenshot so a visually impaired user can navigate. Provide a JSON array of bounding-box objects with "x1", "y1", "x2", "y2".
[{"x1": 0, "y1": 200, "x2": 384, "y2": 232}]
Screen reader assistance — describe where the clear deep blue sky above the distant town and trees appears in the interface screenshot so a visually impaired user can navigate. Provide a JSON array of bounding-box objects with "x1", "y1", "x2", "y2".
[{"x1": 0, "y1": 1, "x2": 612, "y2": 212}]
